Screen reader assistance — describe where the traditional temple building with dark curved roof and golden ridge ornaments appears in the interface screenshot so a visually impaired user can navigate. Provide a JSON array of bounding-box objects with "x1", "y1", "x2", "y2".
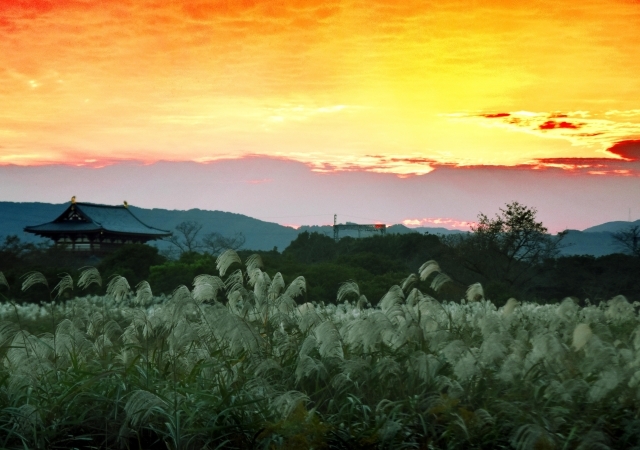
[{"x1": 24, "y1": 196, "x2": 171, "y2": 253}]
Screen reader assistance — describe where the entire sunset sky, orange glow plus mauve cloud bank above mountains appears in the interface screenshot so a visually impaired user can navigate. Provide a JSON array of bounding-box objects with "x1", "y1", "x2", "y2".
[{"x1": 0, "y1": 0, "x2": 640, "y2": 234}]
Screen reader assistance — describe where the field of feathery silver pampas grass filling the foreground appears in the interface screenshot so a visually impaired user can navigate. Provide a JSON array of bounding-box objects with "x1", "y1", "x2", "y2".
[{"x1": 0, "y1": 251, "x2": 640, "y2": 449}]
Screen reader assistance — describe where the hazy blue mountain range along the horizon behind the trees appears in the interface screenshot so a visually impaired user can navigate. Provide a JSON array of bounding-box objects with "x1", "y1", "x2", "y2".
[{"x1": 0, "y1": 202, "x2": 640, "y2": 256}]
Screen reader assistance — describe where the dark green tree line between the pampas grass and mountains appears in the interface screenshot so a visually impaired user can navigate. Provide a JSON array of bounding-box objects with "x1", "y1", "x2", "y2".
[{"x1": 0, "y1": 202, "x2": 640, "y2": 305}]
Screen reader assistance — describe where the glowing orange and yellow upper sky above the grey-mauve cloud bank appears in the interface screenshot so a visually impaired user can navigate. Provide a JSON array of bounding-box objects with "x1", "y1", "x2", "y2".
[{"x1": 0, "y1": 0, "x2": 640, "y2": 176}]
